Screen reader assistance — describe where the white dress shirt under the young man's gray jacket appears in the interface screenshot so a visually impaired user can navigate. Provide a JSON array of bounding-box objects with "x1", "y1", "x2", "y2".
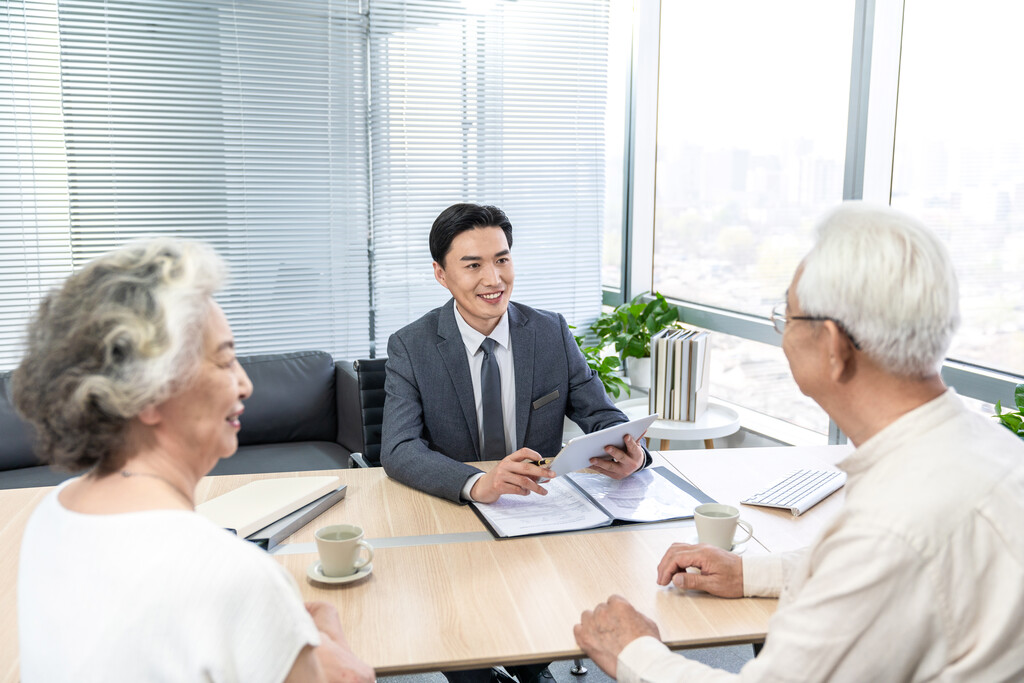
[{"x1": 455, "y1": 303, "x2": 516, "y2": 501}]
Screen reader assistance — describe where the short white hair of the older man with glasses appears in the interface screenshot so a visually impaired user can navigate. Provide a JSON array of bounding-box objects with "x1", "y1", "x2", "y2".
[{"x1": 797, "y1": 202, "x2": 959, "y2": 377}]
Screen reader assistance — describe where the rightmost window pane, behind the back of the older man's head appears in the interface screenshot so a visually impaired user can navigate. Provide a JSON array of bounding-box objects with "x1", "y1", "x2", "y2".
[{"x1": 892, "y1": 0, "x2": 1024, "y2": 375}]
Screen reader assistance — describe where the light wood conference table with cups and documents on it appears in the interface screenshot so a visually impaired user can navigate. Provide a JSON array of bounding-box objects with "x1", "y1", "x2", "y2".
[{"x1": 0, "y1": 446, "x2": 847, "y2": 681}]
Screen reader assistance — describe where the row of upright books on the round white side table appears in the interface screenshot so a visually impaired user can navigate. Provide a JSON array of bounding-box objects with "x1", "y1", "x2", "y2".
[{"x1": 649, "y1": 328, "x2": 711, "y2": 422}]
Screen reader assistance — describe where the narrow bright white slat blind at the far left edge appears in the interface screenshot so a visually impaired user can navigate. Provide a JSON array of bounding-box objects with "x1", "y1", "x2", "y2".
[{"x1": 0, "y1": 2, "x2": 71, "y2": 371}]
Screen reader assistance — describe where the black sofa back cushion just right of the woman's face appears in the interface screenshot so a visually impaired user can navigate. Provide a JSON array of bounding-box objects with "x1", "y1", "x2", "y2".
[{"x1": 239, "y1": 351, "x2": 338, "y2": 448}]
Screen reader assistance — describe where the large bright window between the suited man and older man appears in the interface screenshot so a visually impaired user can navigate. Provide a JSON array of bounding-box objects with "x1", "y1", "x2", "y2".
[{"x1": 653, "y1": 0, "x2": 854, "y2": 433}]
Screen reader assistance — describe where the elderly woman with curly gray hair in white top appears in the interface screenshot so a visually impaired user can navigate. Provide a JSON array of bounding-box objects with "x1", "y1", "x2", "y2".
[{"x1": 13, "y1": 240, "x2": 374, "y2": 683}]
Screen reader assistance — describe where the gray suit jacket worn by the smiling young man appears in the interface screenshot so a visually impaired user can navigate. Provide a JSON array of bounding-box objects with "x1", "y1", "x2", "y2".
[{"x1": 381, "y1": 300, "x2": 650, "y2": 502}]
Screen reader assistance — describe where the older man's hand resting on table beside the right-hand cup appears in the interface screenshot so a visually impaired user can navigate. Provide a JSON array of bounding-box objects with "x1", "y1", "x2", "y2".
[{"x1": 657, "y1": 543, "x2": 743, "y2": 598}]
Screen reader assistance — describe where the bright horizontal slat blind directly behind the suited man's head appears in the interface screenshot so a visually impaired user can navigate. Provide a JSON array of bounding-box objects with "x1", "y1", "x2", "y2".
[{"x1": 370, "y1": 0, "x2": 608, "y2": 353}]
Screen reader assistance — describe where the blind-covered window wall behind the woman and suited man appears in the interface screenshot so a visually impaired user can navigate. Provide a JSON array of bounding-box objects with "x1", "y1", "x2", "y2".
[{"x1": 0, "y1": 0, "x2": 622, "y2": 370}]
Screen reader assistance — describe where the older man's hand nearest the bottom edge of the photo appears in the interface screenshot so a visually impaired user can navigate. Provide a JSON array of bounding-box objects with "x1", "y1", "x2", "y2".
[{"x1": 572, "y1": 595, "x2": 662, "y2": 678}]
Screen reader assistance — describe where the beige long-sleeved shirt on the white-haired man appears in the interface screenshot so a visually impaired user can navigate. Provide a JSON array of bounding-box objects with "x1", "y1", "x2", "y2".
[{"x1": 618, "y1": 390, "x2": 1024, "y2": 683}]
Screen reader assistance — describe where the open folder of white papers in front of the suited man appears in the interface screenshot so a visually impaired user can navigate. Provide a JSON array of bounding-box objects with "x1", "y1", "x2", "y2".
[{"x1": 472, "y1": 467, "x2": 715, "y2": 539}]
